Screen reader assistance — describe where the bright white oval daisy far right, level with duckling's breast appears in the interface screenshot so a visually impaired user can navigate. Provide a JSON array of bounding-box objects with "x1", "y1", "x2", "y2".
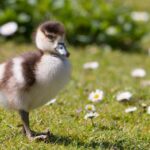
[{"x1": 131, "y1": 68, "x2": 146, "y2": 78}]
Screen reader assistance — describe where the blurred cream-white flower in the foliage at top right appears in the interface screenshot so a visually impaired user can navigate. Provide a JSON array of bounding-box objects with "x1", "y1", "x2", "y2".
[{"x1": 131, "y1": 11, "x2": 149, "y2": 22}]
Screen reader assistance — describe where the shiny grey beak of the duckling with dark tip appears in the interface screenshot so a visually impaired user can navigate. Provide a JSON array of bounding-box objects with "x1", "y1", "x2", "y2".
[{"x1": 56, "y1": 43, "x2": 70, "y2": 57}]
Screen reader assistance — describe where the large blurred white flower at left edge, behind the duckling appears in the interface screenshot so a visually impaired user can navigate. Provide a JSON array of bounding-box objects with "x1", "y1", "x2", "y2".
[{"x1": 0, "y1": 21, "x2": 18, "y2": 36}]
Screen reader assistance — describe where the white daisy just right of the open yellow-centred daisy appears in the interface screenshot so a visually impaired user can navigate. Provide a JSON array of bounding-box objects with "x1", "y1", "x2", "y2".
[{"x1": 116, "y1": 91, "x2": 132, "y2": 102}]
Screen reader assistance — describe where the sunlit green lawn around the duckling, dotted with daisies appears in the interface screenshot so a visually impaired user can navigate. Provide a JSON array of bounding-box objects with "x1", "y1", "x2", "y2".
[{"x1": 0, "y1": 43, "x2": 150, "y2": 150}]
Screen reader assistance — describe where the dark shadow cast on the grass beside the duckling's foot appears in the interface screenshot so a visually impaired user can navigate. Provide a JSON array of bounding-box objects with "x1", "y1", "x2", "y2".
[{"x1": 46, "y1": 135, "x2": 124, "y2": 149}]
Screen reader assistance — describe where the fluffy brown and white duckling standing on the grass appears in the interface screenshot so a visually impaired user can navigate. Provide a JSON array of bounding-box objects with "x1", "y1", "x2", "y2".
[{"x1": 0, "y1": 21, "x2": 70, "y2": 139}]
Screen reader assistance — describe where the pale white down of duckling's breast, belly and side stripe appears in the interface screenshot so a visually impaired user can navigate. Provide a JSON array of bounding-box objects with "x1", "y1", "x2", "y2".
[{"x1": 0, "y1": 54, "x2": 70, "y2": 111}]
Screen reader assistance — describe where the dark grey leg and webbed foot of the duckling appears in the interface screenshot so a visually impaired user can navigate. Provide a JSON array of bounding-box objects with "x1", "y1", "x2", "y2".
[{"x1": 19, "y1": 110, "x2": 50, "y2": 140}]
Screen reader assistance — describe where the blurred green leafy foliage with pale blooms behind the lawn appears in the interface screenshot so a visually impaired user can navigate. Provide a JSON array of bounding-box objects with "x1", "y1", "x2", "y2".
[{"x1": 0, "y1": 0, "x2": 150, "y2": 50}]
